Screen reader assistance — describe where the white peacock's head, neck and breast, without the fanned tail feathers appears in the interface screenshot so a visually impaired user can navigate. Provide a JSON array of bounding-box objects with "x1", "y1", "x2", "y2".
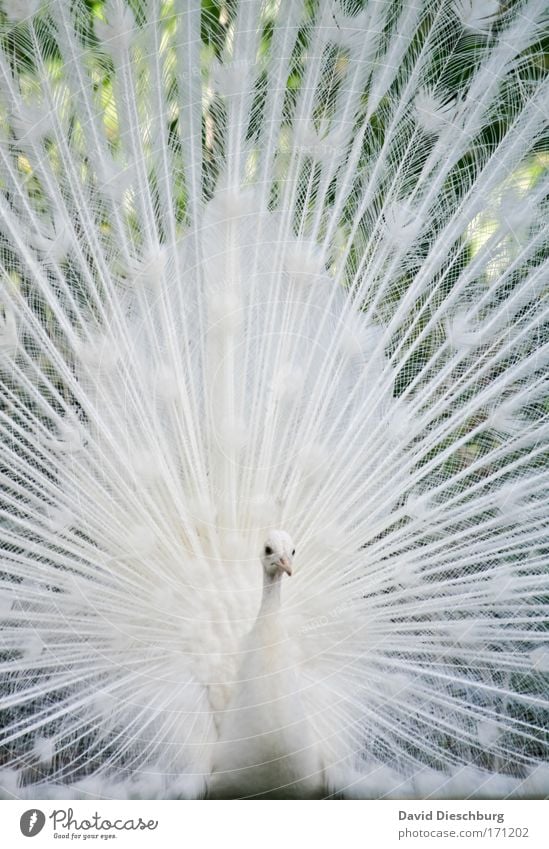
[{"x1": 209, "y1": 531, "x2": 327, "y2": 799}]
